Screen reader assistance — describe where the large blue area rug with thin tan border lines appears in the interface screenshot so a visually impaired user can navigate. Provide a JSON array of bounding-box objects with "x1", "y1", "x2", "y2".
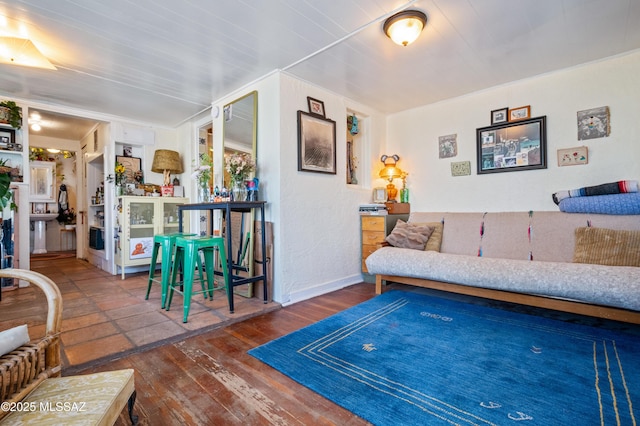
[{"x1": 249, "y1": 291, "x2": 640, "y2": 426}]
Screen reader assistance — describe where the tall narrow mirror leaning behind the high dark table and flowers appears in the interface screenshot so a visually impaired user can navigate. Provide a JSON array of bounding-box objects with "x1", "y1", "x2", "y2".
[{"x1": 222, "y1": 91, "x2": 258, "y2": 293}]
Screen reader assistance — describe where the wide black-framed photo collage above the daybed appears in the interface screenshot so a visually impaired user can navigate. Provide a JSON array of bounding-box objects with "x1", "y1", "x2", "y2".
[{"x1": 476, "y1": 116, "x2": 547, "y2": 175}]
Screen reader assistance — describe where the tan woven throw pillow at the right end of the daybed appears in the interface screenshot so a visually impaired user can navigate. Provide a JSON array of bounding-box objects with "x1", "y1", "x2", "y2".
[{"x1": 573, "y1": 227, "x2": 640, "y2": 266}]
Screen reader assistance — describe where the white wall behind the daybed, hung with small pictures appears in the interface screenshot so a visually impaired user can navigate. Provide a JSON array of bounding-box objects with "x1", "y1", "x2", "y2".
[{"x1": 378, "y1": 52, "x2": 640, "y2": 211}]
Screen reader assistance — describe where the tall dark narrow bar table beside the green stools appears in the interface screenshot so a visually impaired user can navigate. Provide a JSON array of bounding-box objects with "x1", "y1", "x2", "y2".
[{"x1": 178, "y1": 201, "x2": 268, "y2": 313}]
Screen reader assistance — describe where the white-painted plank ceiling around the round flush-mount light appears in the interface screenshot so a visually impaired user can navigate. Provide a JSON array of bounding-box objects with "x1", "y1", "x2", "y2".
[{"x1": 0, "y1": 0, "x2": 640, "y2": 139}]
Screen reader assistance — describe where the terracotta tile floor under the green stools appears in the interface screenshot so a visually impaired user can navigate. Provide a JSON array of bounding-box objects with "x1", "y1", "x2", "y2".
[{"x1": 0, "y1": 258, "x2": 280, "y2": 373}]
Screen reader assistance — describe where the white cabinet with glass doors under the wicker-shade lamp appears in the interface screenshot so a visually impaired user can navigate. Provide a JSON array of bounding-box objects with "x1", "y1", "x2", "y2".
[{"x1": 115, "y1": 196, "x2": 189, "y2": 279}]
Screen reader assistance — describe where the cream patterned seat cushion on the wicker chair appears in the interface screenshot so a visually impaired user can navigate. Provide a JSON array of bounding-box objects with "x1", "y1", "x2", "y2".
[{"x1": 1, "y1": 369, "x2": 135, "y2": 426}]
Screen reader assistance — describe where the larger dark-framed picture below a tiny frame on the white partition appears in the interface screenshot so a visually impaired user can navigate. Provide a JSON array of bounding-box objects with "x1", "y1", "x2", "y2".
[{"x1": 298, "y1": 111, "x2": 336, "y2": 175}]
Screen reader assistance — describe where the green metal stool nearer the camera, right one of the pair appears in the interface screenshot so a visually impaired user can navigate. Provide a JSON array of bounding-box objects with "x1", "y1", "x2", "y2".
[{"x1": 167, "y1": 236, "x2": 229, "y2": 322}]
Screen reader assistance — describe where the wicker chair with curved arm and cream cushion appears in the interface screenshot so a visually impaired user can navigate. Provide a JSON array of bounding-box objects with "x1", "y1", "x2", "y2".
[{"x1": 0, "y1": 269, "x2": 137, "y2": 425}]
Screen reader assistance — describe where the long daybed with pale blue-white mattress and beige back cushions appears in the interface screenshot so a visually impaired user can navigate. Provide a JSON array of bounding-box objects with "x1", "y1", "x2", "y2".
[{"x1": 366, "y1": 212, "x2": 640, "y2": 323}]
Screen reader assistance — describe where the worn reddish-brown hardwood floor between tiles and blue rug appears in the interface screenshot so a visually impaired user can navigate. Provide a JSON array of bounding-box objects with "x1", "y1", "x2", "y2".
[{"x1": 80, "y1": 283, "x2": 375, "y2": 426}]
